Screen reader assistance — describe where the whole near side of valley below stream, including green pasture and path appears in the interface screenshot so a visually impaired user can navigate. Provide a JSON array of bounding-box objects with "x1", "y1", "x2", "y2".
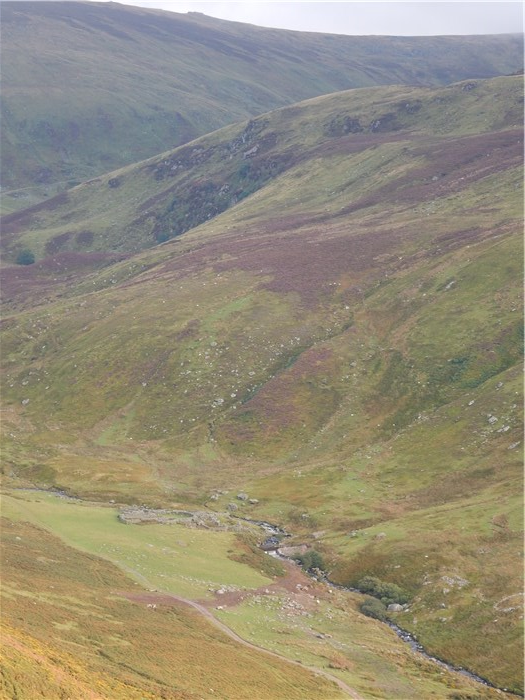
[{"x1": 2, "y1": 491, "x2": 508, "y2": 700}]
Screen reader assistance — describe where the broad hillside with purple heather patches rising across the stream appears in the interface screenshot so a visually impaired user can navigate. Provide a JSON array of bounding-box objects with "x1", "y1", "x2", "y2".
[{"x1": 2, "y1": 77, "x2": 523, "y2": 697}]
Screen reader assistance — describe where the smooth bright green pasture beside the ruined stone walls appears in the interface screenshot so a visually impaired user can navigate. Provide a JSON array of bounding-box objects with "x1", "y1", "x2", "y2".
[{"x1": 2, "y1": 492, "x2": 270, "y2": 599}]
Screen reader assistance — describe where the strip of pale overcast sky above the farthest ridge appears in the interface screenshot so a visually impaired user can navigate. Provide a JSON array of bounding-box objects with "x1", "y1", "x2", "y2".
[{"x1": 81, "y1": 0, "x2": 523, "y2": 36}]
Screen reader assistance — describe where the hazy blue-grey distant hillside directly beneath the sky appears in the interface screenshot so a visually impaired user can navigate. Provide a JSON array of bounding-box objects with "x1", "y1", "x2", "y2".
[{"x1": 1, "y1": 1, "x2": 523, "y2": 211}]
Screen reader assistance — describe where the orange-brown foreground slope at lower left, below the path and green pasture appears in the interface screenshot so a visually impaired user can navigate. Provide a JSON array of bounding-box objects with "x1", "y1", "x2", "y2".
[{"x1": 0, "y1": 508, "x2": 352, "y2": 700}]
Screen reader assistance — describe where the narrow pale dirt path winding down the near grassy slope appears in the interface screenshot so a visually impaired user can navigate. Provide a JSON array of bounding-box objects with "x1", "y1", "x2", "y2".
[{"x1": 119, "y1": 584, "x2": 364, "y2": 700}]
